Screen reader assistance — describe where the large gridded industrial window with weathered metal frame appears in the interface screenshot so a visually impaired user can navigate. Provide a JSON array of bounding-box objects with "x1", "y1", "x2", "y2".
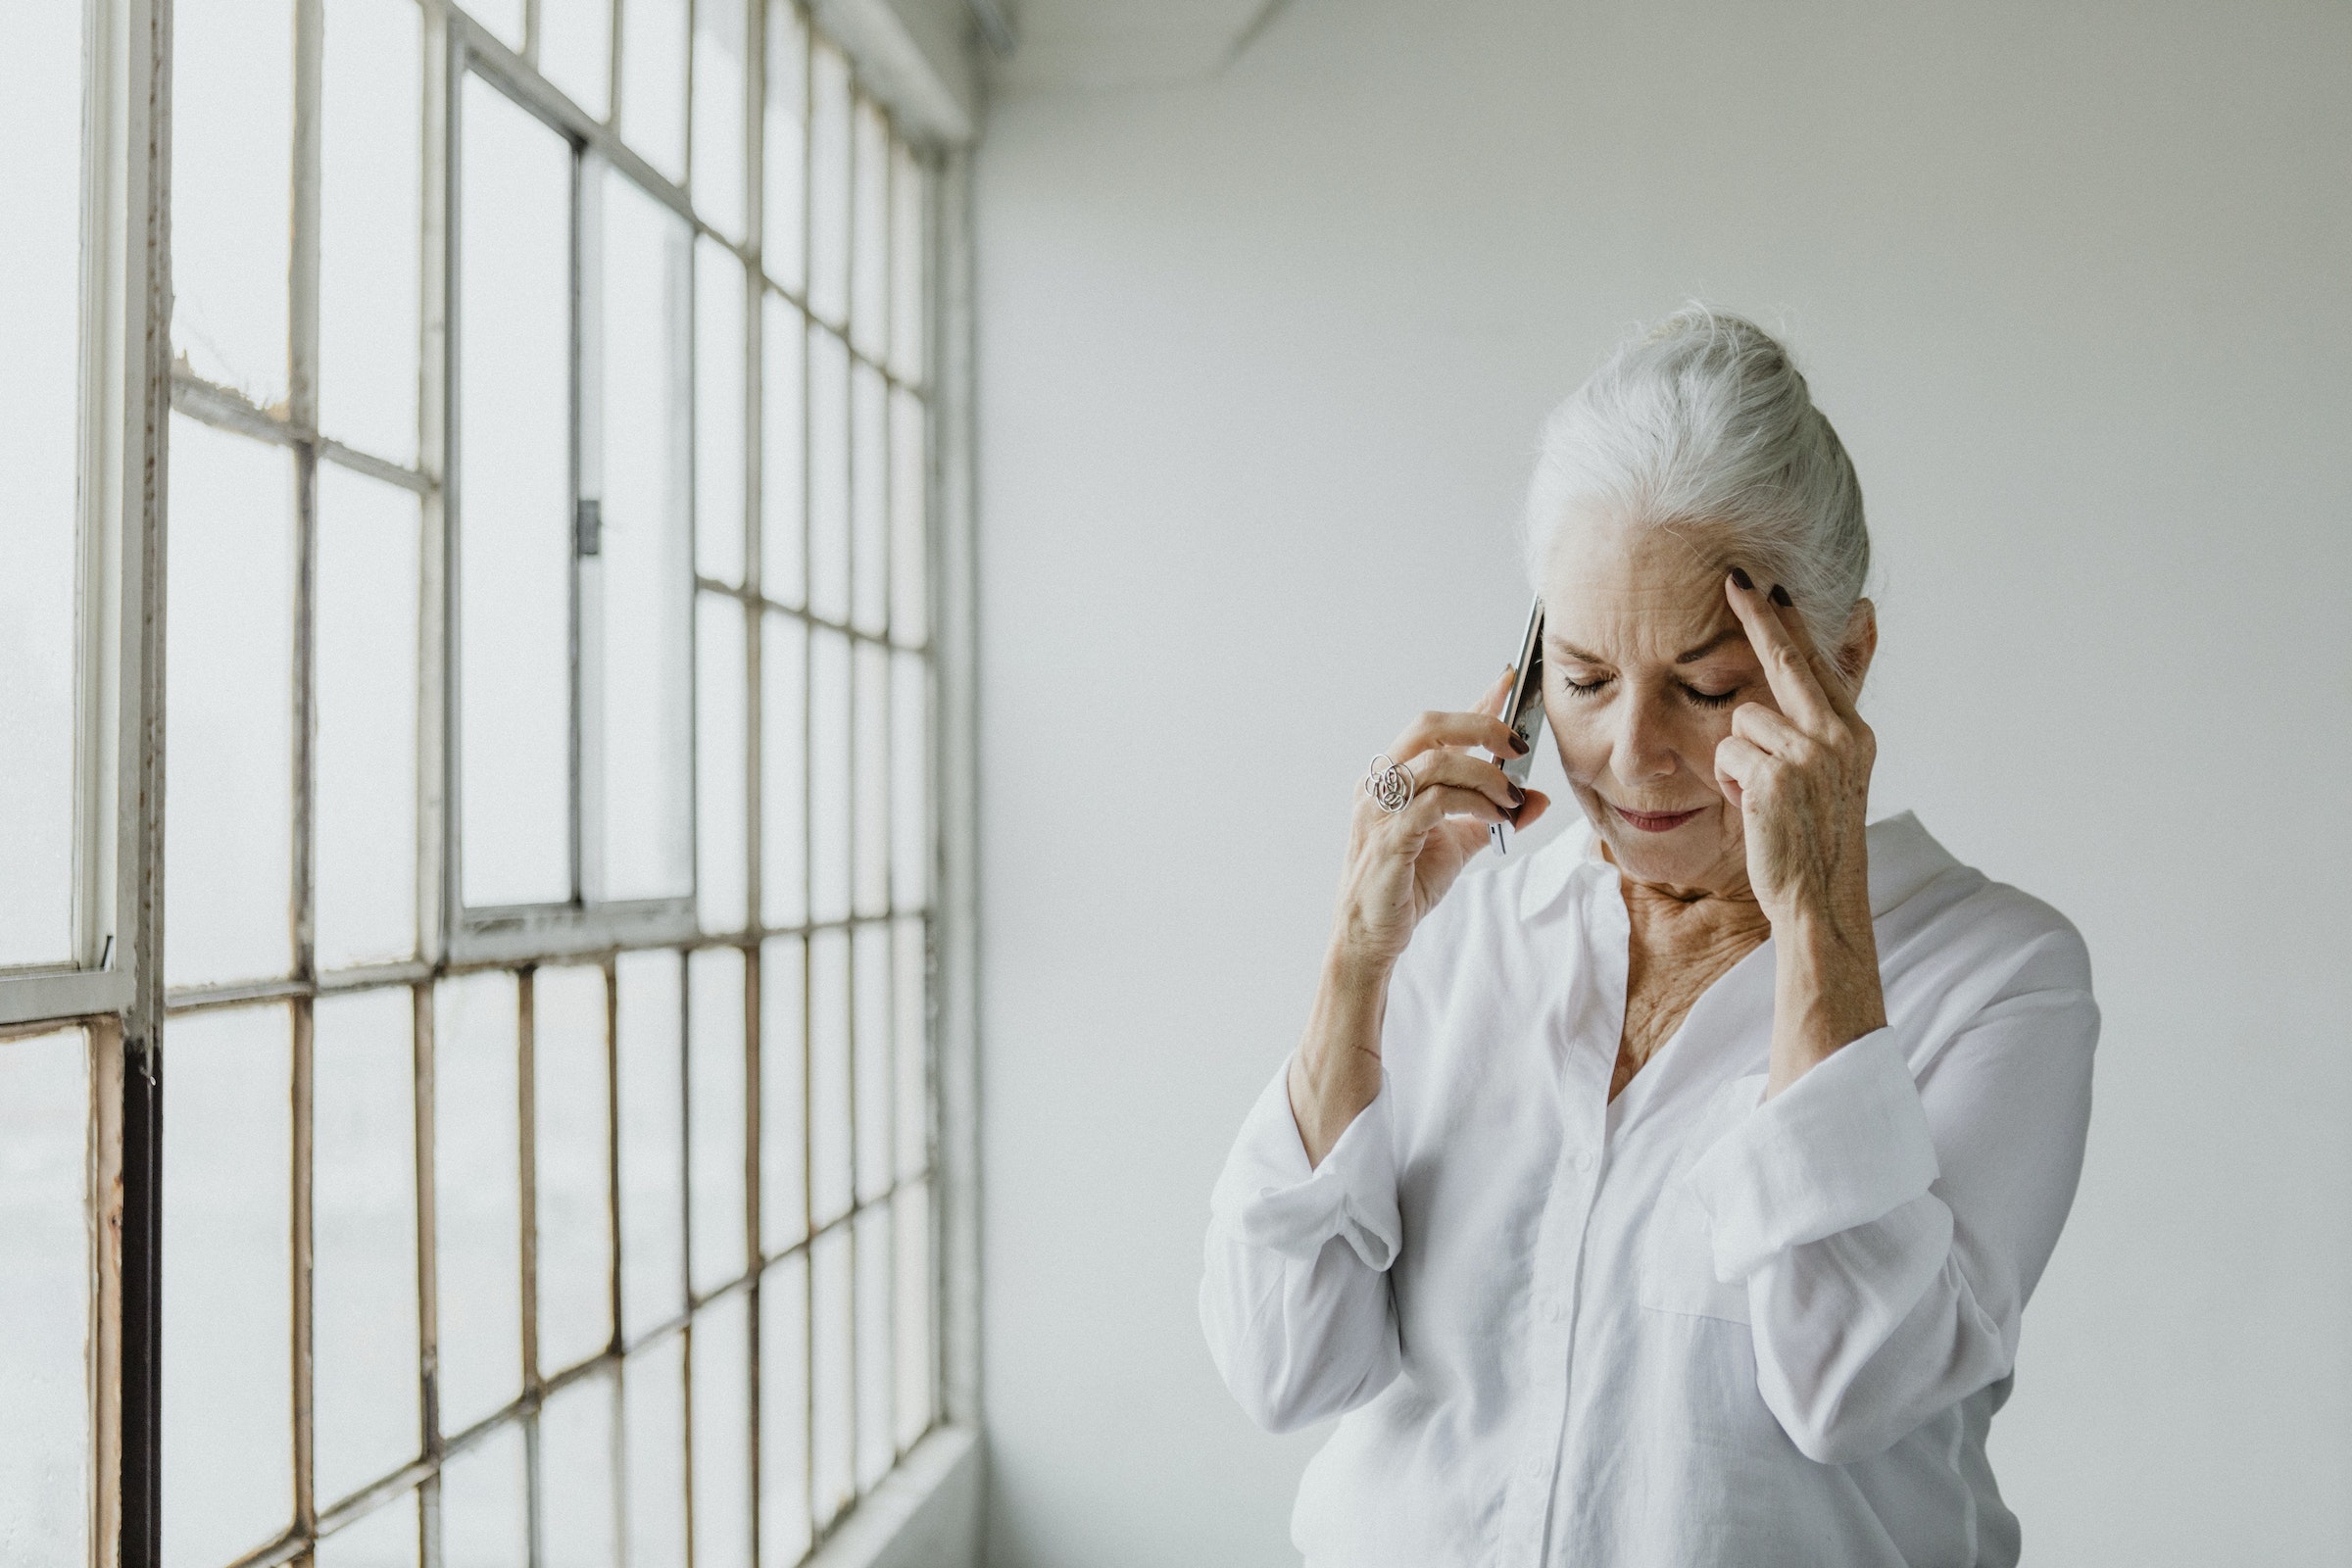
[{"x1": 0, "y1": 0, "x2": 964, "y2": 1568}]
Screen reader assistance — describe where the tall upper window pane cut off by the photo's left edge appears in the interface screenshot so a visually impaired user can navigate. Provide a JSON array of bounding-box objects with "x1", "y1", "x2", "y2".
[{"x1": 0, "y1": 5, "x2": 82, "y2": 966}]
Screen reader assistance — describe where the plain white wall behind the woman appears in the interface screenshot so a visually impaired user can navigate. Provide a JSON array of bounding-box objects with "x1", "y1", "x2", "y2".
[{"x1": 976, "y1": 0, "x2": 2352, "y2": 1568}]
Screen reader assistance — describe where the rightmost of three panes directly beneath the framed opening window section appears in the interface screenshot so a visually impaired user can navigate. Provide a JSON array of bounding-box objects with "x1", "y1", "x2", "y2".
[{"x1": 618, "y1": 953, "x2": 687, "y2": 1340}]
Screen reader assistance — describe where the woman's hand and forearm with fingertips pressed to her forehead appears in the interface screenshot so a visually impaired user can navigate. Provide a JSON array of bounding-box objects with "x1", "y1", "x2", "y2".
[{"x1": 1715, "y1": 578, "x2": 1886, "y2": 1096}]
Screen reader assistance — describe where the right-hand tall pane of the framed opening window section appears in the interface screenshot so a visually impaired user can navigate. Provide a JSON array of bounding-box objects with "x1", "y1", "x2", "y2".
[{"x1": 598, "y1": 170, "x2": 694, "y2": 898}]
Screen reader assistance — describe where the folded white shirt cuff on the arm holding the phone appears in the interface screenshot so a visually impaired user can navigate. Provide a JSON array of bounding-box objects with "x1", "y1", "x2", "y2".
[{"x1": 1216, "y1": 1065, "x2": 1404, "y2": 1269}]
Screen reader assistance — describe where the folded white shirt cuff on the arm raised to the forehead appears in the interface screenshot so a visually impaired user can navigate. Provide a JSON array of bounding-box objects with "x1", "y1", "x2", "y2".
[{"x1": 1689, "y1": 1030, "x2": 1938, "y2": 1284}]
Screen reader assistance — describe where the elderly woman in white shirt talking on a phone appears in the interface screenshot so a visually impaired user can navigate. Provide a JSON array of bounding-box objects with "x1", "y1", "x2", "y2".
[{"x1": 1201, "y1": 311, "x2": 2098, "y2": 1568}]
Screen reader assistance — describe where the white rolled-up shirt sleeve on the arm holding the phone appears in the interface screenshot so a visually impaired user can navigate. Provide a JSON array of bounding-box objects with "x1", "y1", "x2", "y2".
[{"x1": 1200, "y1": 1069, "x2": 1404, "y2": 1432}]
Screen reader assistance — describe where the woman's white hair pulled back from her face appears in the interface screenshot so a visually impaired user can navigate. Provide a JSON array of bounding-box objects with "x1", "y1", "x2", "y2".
[{"x1": 1522, "y1": 306, "x2": 1870, "y2": 649}]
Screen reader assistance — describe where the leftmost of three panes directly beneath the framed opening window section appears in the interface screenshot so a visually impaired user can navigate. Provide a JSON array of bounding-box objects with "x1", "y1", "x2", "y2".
[{"x1": 433, "y1": 973, "x2": 522, "y2": 1432}]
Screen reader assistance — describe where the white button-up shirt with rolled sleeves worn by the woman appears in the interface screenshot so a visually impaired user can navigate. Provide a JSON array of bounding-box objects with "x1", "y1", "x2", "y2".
[{"x1": 1200, "y1": 815, "x2": 2098, "y2": 1568}]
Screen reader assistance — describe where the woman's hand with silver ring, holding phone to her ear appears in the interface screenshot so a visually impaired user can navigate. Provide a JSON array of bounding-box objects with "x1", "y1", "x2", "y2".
[{"x1": 1331, "y1": 670, "x2": 1550, "y2": 978}]
